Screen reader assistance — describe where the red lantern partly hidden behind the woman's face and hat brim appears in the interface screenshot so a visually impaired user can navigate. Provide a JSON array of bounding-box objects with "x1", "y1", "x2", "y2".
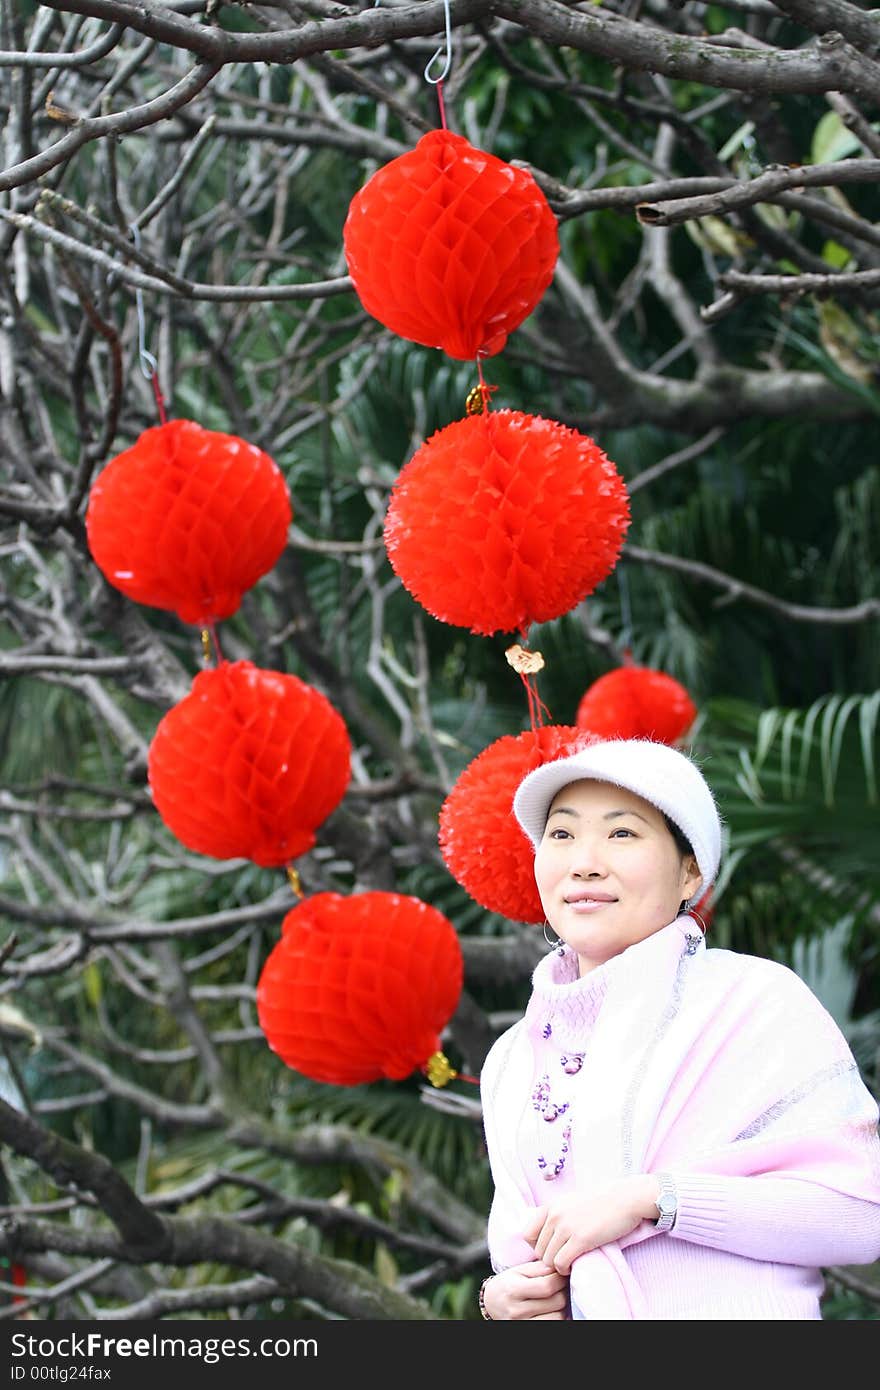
[{"x1": 439, "y1": 724, "x2": 591, "y2": 922}]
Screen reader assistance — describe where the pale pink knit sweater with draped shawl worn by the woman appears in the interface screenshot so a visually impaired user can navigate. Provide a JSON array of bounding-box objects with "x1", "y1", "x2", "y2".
[{"x1": 481, "y1": 920, "x2": 880, "y2": 1321}]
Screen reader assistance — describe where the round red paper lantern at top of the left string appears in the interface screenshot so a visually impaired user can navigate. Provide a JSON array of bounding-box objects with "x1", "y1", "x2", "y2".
[{"x1": 86, "y1": 420, "x2": 292, "y2": 627}]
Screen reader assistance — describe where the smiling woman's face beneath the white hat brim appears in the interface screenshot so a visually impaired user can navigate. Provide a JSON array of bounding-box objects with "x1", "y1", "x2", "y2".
[{"x1": 535, "y1": 781, "x2": 702, "y2": 976}]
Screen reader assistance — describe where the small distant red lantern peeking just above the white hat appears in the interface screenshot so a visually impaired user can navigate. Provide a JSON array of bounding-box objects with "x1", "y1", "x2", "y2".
[{"x1": 576, "y1": 664, "x2": 696, "y2": 744}]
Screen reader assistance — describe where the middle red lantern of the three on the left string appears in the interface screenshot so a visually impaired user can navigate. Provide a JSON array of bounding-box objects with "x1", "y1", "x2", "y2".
[{"x1": 147, "y1": 662, "x2": 350, "y2": 867}]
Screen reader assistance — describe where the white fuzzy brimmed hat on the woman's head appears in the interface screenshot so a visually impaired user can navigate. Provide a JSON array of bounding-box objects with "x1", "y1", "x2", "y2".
[{"x1": 513, "y1": 738, "x2": 722, "y2": 892}]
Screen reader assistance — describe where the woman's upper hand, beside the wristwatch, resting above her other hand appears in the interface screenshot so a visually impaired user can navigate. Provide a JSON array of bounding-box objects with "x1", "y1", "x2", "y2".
[{"x1": 523, "y1": 1173, "x2": 660, "y2": 1275}]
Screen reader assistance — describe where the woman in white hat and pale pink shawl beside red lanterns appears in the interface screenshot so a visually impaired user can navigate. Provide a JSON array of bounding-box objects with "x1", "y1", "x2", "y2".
[{"x1": 480, "y1": 739, "x2": 880, "y2": 1321}]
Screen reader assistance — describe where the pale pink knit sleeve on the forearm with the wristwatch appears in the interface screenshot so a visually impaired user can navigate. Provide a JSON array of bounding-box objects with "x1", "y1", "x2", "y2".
[{"x1": 669, "y1": 1172, "x2": 880, "y2": 1268}]
